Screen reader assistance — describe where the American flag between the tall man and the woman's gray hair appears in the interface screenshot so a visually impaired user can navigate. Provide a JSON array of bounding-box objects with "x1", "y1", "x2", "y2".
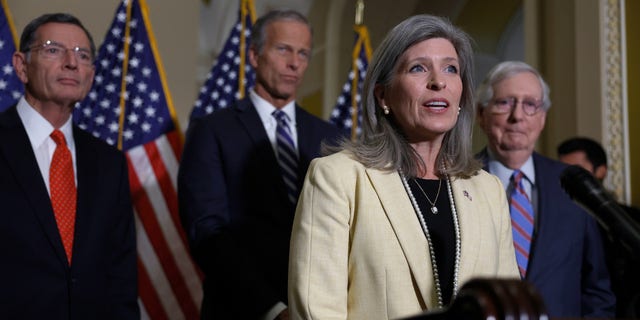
[{"x1": 329, "y1": 24, "x2": 371, "y2": 139}]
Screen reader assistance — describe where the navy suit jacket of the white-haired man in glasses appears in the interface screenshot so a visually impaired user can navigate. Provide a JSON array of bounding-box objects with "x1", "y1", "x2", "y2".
[{"x1": 480, "y1": 150, "x2": 615, "y2": 318}]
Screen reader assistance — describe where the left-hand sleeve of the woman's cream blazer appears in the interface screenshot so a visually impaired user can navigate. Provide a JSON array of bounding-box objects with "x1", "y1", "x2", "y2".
[{"x1": 289, "y1": 159, "x2": 356, "y2": 319}]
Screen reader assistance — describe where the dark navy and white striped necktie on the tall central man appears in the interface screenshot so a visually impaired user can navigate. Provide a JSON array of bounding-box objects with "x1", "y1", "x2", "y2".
[{"x1": 271, "y1": 110, "x2": 298, "y2": 204}]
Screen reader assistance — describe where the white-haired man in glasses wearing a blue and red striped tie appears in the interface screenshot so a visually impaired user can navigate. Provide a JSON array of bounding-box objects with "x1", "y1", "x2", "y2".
[{"x1": 476, "y1": 61, "x2": 615, "y2": 318}]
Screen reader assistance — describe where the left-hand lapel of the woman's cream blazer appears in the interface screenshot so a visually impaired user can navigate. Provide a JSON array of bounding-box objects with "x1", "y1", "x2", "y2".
[{"x1": 367, "y1": 169, "x2": 437, "y2": 309}]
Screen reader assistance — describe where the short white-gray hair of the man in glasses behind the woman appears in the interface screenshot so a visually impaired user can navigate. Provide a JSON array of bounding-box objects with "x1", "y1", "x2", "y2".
[{"x1": 476, "y1": 61, "x2": 551, "y2": 111}]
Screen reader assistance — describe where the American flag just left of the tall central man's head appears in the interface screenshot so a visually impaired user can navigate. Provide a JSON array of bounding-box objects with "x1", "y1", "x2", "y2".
[{"x1": 190, "y1": 0, "x2": 256, "y2": 120}]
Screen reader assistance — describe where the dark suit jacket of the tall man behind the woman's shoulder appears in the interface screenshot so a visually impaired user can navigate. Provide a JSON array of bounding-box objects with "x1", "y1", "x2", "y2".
[{"x1": 178, "y1": 99, "x2": 339, "y2": 319}]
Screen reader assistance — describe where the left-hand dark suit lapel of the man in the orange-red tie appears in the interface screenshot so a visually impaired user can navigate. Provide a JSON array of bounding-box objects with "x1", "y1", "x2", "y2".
[{"x1": 0, "y1": 107, "x2": 67, "y2": 265}]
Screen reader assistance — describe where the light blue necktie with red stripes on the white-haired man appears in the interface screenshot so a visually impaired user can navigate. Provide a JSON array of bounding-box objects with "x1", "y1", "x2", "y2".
[{"x1": 509, "y1": 170, "x2": 533, "y2": 279}]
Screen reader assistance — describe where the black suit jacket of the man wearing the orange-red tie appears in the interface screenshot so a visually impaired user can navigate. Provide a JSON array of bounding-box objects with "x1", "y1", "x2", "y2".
[{"x1": 0, "y1": 107, "x2": 139, "y2": 319}]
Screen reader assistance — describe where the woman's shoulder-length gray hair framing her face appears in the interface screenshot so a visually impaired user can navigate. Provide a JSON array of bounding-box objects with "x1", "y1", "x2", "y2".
[{"x1": 325, "y1": 14, "x2": 481, "y2": 178}]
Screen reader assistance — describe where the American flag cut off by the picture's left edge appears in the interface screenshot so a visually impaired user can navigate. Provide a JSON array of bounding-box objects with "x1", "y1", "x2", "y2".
[{"x1": 0, "y1": 0, "x2": 24, "y2": 112}]
